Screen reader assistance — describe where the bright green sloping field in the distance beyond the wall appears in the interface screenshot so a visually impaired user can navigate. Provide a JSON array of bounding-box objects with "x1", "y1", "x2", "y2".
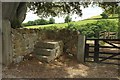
[{"x1": 24, "y1": 16, "x2": 118, "y2": 28}]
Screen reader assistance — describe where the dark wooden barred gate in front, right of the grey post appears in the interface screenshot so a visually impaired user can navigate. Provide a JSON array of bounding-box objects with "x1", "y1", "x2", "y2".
[{"x1": 85, "y1": 39, "x2": 120, "y2": 65}]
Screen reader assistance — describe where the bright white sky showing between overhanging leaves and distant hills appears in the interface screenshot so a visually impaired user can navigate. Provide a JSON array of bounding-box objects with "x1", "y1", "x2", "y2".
[{"x1": 23, "y1": 5, "x2": 103, "y2": 23}]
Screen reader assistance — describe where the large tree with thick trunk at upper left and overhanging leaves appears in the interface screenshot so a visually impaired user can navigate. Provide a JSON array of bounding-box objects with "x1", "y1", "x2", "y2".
[{"x1": 2, "y1": 1, "x2": 90, "y2": 28}]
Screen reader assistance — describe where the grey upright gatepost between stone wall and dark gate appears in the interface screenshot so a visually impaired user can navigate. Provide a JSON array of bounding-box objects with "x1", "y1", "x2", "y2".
[{"x1": 77, "y1": 35, "x2": 85, "y2": 63}]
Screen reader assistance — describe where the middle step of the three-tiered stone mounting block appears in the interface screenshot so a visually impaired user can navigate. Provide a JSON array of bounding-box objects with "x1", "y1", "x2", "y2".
[{"x1": 34, "y1": 48, "x2": 56, "y2": 56}]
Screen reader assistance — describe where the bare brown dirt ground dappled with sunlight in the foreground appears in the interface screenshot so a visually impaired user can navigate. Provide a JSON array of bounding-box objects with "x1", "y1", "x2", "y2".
[{"x1": 2, "y1": 55, "x2": 120, "y2": 78}]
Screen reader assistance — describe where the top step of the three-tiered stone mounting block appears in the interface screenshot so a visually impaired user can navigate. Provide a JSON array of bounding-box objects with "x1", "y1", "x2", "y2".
[{"x1": 35, "y1": 41, "x2": 60, "y2": 49}]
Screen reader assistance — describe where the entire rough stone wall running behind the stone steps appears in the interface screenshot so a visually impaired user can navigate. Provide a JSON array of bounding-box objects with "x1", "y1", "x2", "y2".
[{"x1": 12, "y1": 29, "x2": 78, "y2": 62}]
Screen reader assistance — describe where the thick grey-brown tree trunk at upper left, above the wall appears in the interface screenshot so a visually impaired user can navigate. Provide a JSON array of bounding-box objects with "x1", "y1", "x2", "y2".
[{"x1": 2, "y1": 2, "x2": 27, "y2": 28}]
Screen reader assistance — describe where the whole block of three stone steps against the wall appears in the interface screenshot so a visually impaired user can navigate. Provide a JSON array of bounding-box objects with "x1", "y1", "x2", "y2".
[{"x1": 34, "y1": 41, "x2": 63, "y2": 62}]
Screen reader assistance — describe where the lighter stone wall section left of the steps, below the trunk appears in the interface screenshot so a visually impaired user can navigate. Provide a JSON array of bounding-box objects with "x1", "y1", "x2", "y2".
[{"x1": 12, "y1": 29, "x2": 46, "y2": 62}]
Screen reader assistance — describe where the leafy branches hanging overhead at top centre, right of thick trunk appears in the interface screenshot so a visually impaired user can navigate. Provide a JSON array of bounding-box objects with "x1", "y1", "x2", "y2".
[{"x1": 28, "y1": 1, "x2": 90, "y2": 17}]
